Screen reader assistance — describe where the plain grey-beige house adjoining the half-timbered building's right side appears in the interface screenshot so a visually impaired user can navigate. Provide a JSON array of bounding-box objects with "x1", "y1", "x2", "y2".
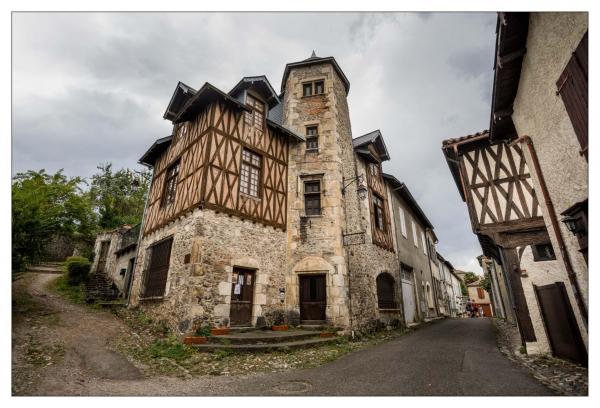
[{"x1": 383, "y1": 174, "x2": 437, "y2": 324}]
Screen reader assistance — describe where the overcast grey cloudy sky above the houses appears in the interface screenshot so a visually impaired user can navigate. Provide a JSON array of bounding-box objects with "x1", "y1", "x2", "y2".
[{"x1": 12, "y1": 13, "x2": 496, "y2": 272}]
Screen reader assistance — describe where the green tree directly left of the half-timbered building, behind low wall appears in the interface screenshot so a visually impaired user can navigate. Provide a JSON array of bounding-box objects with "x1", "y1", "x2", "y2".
[{"x1": 89, "y1": 163, "x2": 152, "y2": 229}]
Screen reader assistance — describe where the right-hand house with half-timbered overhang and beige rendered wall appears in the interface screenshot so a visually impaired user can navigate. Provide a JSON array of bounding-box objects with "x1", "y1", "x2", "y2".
[{"x1": 443, "y1": 13, "x2": 588, "y2": 364}]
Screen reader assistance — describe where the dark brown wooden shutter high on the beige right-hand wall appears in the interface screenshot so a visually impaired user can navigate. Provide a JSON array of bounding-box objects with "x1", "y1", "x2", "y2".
[{"x1": 556, "y1": 33, "x2": 588, "y2": 160}]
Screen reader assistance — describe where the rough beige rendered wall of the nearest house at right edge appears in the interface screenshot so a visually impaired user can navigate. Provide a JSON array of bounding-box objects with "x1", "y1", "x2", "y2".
[{"x1": 512, "y1": 13, "x2": 589, "y2": 350}]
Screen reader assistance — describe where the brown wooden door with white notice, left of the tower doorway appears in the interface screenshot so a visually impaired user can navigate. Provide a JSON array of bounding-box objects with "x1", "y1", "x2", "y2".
[{"x1": 229, "y1": 268, "x2": 255, "y2": 326}]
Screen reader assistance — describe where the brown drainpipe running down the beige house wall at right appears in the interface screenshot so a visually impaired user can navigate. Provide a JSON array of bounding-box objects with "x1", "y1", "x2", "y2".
[{"x1": 509, "y1": 135, "x2": 588, "y2": 331}]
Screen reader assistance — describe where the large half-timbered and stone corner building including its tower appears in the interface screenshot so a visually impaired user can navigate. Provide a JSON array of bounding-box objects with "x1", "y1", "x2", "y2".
[{"x1": 89, "y1": 53, "x2": 437, "y2": 333}]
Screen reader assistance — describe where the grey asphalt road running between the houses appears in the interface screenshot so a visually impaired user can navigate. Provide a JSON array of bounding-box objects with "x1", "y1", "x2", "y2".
[{"x1": 225, "y1": 319, "x2": 552, "y2": 395}]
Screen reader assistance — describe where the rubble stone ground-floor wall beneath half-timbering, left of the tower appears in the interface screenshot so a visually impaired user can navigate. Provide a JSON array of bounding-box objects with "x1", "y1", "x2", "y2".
[{"x1": 130, "y1": 209, "x2": 286, "y2": 334}]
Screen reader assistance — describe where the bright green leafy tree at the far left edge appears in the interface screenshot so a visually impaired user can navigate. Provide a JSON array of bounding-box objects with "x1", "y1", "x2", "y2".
[{"x1": 11, "y1": 169, "x2": 96, "y2": 271}]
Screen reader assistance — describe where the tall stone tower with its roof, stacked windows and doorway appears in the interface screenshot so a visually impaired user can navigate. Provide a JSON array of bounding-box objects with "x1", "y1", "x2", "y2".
[{"x1": 282, "y1": 51, "x2": 358, "y2": 327}]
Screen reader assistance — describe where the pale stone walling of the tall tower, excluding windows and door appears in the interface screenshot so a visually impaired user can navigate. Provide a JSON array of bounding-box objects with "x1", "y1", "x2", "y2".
[{"x1": 284, "y1": 64, "x2": 351, "y2": 327}]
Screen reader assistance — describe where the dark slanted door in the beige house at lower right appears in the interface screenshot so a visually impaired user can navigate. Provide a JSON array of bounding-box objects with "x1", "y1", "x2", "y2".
[{"x1": 533, "y1": 282, "x2": 587, "y2": 366}]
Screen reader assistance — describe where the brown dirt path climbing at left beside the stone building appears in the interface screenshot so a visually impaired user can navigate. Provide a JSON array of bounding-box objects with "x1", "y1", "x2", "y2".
[{"x1": 12, "y1": 273, "x2": 276, "y2": 395}]
